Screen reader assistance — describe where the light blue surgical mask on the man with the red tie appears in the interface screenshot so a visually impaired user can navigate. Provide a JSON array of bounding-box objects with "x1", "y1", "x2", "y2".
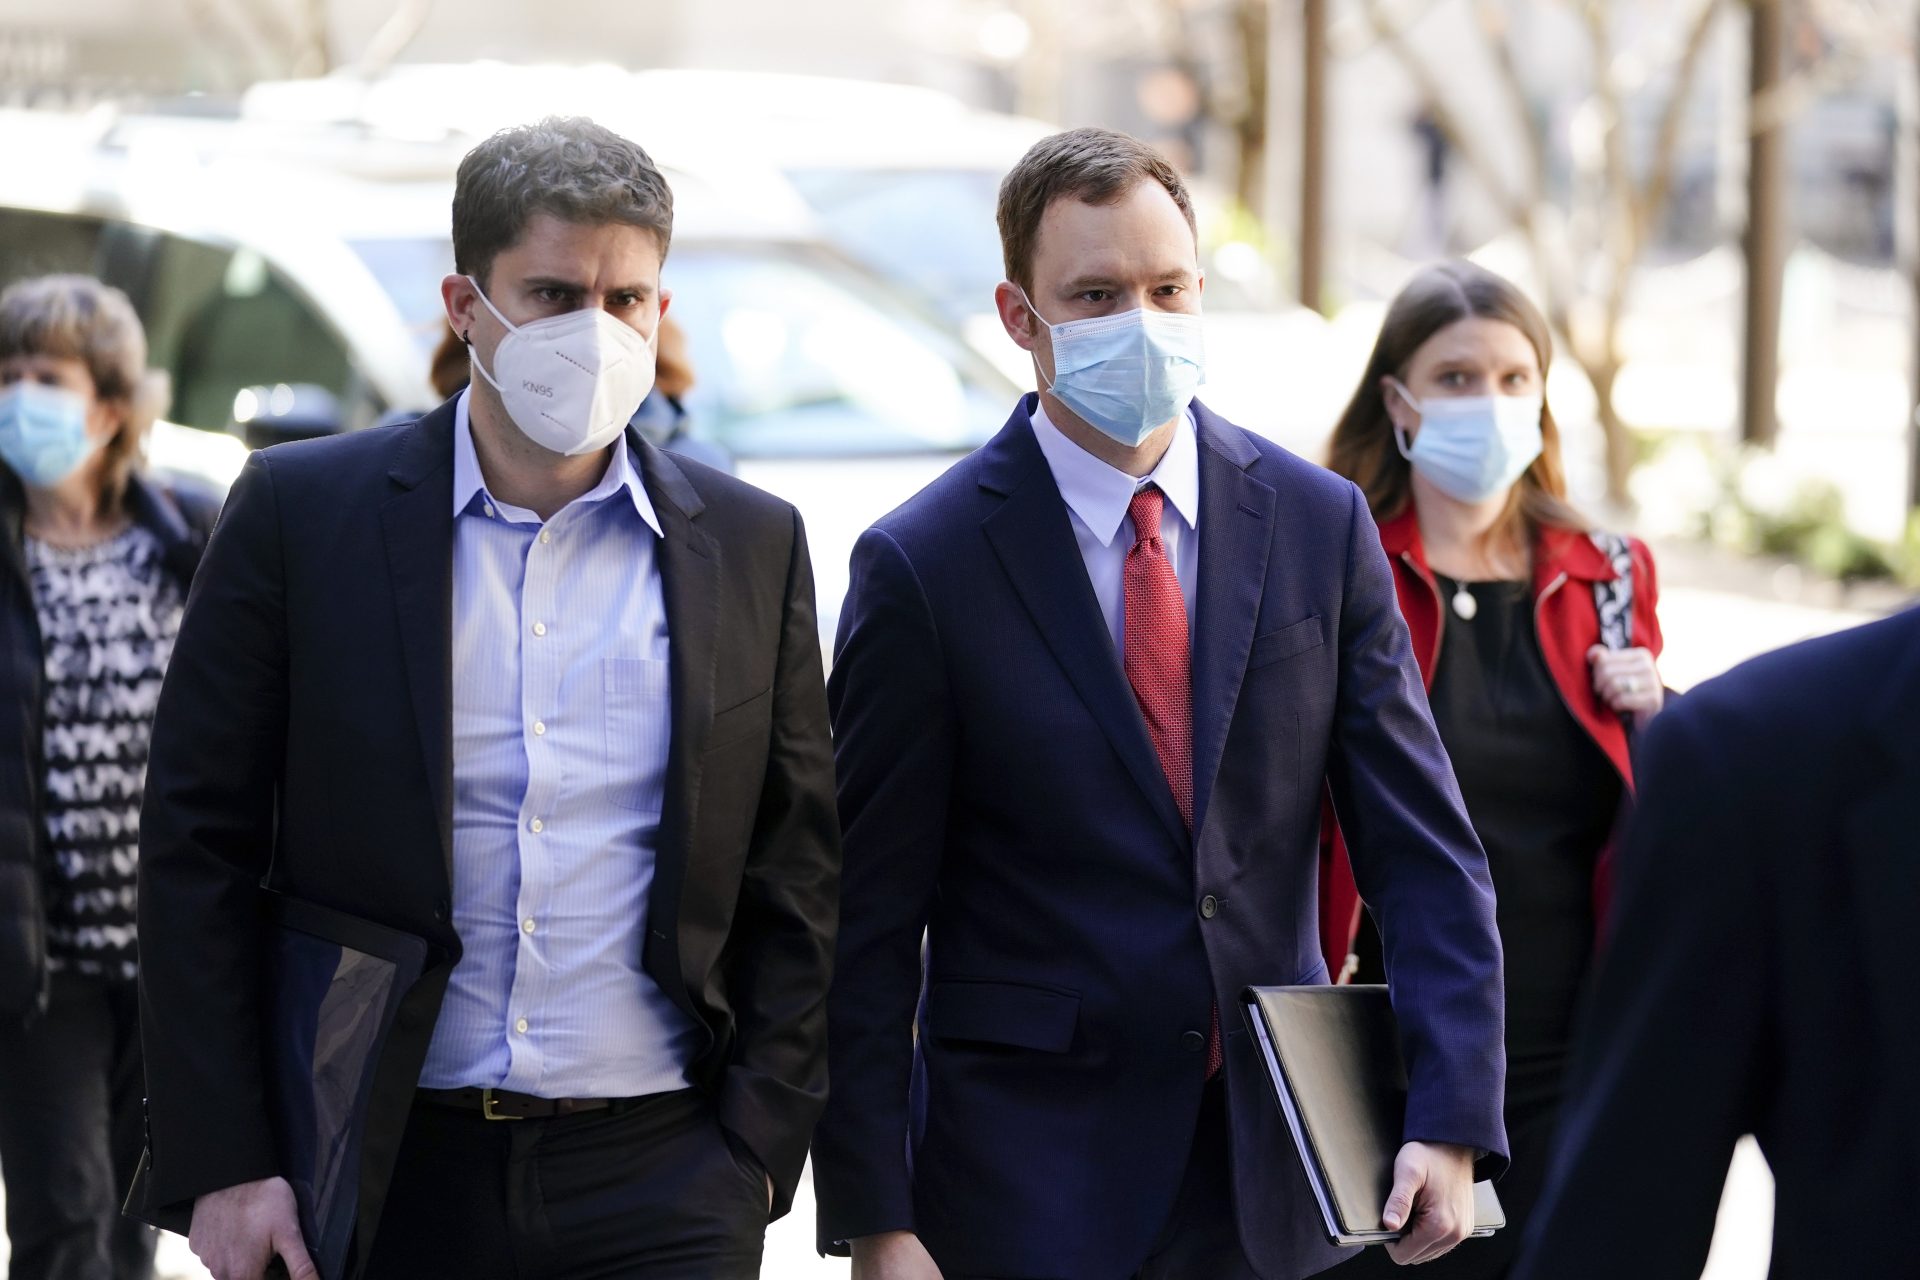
[{"x1": 1016, "y1": 286, "x2": 1206, "y2": 449}]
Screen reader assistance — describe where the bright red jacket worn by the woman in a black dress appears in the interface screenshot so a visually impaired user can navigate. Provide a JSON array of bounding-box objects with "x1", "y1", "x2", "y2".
[{"x1": 1319, "y1": 507, "x2": 1661, "y2": 981}]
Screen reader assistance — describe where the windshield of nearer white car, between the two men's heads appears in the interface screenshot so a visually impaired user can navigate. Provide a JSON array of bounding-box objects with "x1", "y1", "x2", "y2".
[{"x1": 662, "y1": 244, "x2": 1012, "y2": 457}]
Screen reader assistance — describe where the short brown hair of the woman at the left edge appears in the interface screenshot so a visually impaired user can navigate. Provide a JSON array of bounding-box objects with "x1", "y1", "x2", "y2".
[{"x1": 0, "y1": 276, "x2": 167, "y2": 510}]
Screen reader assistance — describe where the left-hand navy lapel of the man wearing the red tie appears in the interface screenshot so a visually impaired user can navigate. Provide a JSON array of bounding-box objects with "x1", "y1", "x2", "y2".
[{"x1": 981, "y1": 413, "x2": 1190, "y2": 846}]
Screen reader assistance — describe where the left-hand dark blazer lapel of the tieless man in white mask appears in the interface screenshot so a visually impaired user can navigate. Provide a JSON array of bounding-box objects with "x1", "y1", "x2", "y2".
[{"x1": 380, "y1": 401, "x2": 453, "y2": 885}]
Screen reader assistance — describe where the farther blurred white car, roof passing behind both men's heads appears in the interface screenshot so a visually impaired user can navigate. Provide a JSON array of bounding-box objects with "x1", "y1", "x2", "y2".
[{"x1": 246, "y1": 70, "x2": 1359, "y2": 457}]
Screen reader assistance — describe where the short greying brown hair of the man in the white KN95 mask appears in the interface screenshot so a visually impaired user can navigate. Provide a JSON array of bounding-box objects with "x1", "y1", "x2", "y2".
[{"x1": 453, "y1": 115, "x2": 674, "y2": 284}]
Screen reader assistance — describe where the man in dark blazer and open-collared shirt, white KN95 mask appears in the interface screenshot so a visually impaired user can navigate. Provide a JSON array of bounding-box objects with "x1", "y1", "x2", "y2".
[{"x1": 127, "y1": 121, "x2": 839, "y2": 1280}]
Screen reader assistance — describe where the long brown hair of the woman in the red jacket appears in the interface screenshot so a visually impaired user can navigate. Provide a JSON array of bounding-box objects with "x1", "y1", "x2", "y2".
[{"x1": 1327, "y1": 259, "x2": 1592, "y2": 547}]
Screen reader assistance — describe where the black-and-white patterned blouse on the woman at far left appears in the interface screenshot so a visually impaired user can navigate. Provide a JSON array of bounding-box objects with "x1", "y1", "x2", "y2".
[{"x1": 27, "y1": 526, "x2": 184, "y2": 981}]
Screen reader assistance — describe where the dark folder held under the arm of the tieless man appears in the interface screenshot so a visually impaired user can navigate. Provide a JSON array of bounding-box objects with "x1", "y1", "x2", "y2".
[{"x1": 127, "y1": 890, "x2": 428, "y2": 1280}]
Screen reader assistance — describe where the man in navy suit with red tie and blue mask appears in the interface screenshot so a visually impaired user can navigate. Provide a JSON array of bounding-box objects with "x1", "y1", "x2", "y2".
[{"x1": 814, "y1": 130, "x2": 1505, "y2": 1280}]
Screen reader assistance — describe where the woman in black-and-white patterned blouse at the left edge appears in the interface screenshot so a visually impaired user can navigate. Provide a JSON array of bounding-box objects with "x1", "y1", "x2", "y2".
[{"x1": 0, "y1": 276, "x2": 211, "y2": 1280}]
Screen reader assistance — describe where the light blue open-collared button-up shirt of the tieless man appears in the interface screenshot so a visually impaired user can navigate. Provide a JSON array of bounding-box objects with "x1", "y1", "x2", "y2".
[{"x1": 420, "y1": 395, "x2": 699, "y2": 1098}]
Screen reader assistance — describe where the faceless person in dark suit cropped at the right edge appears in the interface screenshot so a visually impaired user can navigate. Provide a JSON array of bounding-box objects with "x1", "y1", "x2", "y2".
[{"x1": 1517, "y1": 610, "x2": 1920, "y2": 1280}]
